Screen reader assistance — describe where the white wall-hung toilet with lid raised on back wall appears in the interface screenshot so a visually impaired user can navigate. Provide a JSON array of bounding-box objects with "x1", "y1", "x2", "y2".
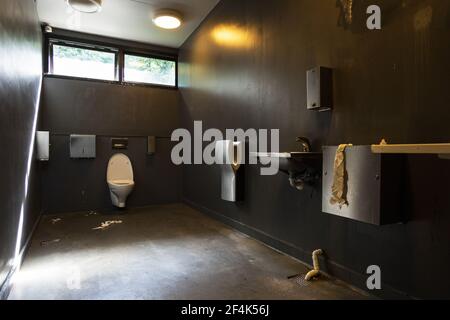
[{"x1": 106, "y1": 153, "x2": 134, "y2": 208}]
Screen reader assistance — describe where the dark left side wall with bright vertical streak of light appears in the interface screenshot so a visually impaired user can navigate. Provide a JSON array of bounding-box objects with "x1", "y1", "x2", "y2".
[{"x1": 0, "y1": 0, "x2": 42, "y2": 287}]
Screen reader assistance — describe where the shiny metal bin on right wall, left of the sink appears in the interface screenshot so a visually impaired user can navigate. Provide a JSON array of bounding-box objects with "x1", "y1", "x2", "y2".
[{"x1": 215, "y1": 140, "x2": 245, "y2": 202}]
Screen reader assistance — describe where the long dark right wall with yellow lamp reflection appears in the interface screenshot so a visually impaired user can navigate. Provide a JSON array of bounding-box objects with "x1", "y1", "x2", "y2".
[{"x1": 180, "y1": 0, "x2": 450, "y2": 298}]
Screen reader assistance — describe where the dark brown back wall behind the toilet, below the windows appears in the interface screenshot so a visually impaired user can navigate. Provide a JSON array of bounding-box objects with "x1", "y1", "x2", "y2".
[{"x1": 40, "y1": 77, "x2": 181, "y2": 213}]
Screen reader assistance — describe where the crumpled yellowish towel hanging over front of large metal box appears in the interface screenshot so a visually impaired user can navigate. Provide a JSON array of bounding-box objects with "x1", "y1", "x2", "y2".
[{"x1": 330, "y1": 144, "x2": 353, "y2": 208}]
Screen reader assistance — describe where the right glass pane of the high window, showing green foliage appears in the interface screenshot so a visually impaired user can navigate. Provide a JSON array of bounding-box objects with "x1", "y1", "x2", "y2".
[{"x1": 123, "y1": 54, "x2": 176, "y2": 86}]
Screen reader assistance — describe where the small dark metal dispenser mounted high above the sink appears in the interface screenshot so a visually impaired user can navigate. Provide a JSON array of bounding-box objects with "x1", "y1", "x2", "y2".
[{"x1": 306, "y1": 67, "x2": 333, "y2": 111}]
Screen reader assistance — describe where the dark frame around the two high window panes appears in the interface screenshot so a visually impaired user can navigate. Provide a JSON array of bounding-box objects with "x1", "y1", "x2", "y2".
[{"x1": 44, "y1": 34, "x2": 178, "y2": 90}]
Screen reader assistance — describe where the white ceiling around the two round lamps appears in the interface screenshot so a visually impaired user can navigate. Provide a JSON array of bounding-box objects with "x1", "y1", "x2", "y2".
[{"x1": 37, "y1": 0, "x2": 220, "y2": 48}]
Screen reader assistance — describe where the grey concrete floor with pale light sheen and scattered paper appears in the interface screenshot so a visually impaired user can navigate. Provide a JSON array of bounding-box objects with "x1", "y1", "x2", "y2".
[{"x1": 9, "y1": 204, "x2": 370, "y2": 299}]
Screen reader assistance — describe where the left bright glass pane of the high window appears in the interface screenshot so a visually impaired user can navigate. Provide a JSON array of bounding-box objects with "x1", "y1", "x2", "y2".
[{"x1": 50, "y1": 44, "x2": 117, "y2": 80}]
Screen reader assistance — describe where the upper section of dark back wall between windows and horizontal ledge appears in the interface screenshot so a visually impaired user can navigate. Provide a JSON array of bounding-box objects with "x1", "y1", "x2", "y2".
[{"x1": 41, "y1": 77, "x2": 180, "y2": 136}]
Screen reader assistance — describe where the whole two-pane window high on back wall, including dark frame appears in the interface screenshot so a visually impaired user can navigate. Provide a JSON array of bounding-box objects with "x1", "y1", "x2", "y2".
[{"x1": 44, "y1": 36, "x2": 177, "y2": 88}]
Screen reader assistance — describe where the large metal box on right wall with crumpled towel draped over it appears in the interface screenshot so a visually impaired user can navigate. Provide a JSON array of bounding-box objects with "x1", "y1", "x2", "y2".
[{"x1": 322, "y1": 146, "x2": 405, "y2": 225}]
